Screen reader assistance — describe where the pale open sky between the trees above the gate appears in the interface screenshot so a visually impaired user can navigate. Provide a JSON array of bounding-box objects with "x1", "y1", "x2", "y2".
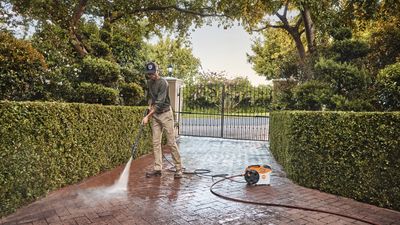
[{"x1": 190, "y1": 23, "x2": 268, "y2": 85}]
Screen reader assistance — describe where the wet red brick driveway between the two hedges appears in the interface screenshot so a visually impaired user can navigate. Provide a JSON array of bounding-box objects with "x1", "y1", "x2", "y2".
[{"x1": 0, "y1": 137, "x2": 400, "y2": 225}]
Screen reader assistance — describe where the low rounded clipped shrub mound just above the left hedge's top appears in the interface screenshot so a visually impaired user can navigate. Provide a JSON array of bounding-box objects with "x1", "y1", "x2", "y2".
[{"x1": 76, "y1": 82, "x2": 119, "y2": 105}]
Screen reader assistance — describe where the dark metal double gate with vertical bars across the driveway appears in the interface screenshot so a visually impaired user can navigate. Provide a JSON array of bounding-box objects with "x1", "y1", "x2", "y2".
[{"x1": 178, "y1": 84, "x2": 271, "y2": 141}]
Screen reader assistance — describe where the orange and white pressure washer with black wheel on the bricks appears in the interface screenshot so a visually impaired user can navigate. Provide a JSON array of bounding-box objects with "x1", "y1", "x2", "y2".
[{"x1": 244, "y1": 165, "x2": 272, "y2": 185}]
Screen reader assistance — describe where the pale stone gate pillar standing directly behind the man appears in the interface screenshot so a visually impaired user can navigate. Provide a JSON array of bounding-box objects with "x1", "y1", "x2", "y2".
[{"x1": 165, "y1": 77, "x2": 183, "y2": 134}]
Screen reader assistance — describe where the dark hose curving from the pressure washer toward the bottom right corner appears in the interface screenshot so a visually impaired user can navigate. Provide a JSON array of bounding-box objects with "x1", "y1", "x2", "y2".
[{"x1": 210, "y1": 175, "x2": 378, "y2": 225}]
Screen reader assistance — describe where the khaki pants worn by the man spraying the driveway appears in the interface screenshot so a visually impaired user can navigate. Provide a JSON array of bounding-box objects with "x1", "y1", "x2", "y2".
[{"x1": 151, "y1": 110, "x2": 182, "y2": 170}]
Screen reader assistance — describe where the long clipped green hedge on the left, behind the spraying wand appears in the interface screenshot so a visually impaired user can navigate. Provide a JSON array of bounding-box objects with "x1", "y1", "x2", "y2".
[{"x1": 0, "y1": 101, "x2": 151, "y2": 216}]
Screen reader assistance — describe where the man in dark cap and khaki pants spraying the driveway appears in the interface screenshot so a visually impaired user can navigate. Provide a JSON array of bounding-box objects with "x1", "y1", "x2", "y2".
[{"x1": 142, "y1": 62, "x2": 182, "y2": 178}]
